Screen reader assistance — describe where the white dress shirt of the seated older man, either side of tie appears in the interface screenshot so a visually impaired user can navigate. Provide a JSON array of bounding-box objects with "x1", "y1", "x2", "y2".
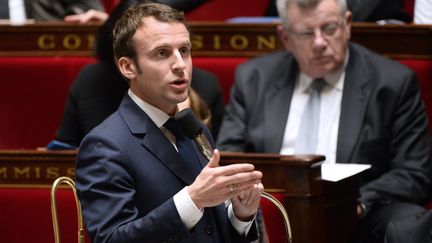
[{"x1": 280, "y1": 53, "x2": 349, "y2": 163}]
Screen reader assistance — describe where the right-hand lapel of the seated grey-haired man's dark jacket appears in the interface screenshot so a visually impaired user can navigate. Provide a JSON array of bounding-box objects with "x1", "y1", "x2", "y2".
[{"x1": 336, "y1": 45, "x2": 370, "y2": 163}]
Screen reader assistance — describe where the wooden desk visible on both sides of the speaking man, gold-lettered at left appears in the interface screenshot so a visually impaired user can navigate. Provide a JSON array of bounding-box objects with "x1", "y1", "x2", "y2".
[{"x1": 0, "y1": 150, "x2": 358, "y2": 243}]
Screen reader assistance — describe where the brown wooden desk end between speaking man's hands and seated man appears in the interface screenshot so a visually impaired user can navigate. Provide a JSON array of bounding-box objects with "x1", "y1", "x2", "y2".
[{"x1": 221, "y1": 152, "x2": 358, "y2": 243}]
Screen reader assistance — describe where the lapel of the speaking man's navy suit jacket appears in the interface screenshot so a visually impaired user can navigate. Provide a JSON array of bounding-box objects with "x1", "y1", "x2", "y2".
[{"x1": 119, "y1": 94, "x2": 195, "y2": 185}]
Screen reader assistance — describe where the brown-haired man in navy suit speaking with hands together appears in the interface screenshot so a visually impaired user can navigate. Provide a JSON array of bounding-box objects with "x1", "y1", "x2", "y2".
[{"x1": 76, "y1": 4, "x2": 264, "y2": 243}]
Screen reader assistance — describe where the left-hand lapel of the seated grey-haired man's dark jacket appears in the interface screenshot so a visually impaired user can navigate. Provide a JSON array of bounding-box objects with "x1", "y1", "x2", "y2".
[{"x1": 263, "y1": 58, "x2": 298, "y2": 153}]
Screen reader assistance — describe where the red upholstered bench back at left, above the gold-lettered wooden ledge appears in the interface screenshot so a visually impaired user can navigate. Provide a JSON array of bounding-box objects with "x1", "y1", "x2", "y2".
[{"x1": 0, "y1": 57, "x2": 95, "y2": 149}]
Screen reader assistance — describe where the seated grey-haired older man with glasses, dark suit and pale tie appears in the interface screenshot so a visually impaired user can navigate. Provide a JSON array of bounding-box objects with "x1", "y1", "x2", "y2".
[{"x1": 217, "y1": 0, "x2": 432, "y2": 242}]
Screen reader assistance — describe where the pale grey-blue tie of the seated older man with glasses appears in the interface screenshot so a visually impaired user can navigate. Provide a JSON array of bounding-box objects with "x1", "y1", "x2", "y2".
[{"x1": 294, "y1": 79, "x2": 326, "y2": 154}]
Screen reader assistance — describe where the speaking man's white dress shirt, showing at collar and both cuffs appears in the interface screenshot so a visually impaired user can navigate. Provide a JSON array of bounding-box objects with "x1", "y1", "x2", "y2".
[{"x1": 128, "y1": 89, "x2": 253, "y2": 235}]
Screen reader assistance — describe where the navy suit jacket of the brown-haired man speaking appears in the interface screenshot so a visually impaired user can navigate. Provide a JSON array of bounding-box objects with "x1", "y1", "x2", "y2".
[{"x1": 76, "y1": 94, "x2": 256, "y2": 243}]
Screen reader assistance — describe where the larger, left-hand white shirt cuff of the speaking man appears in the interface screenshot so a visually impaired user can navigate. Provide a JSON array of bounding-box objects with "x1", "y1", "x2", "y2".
[{"x1": 173, "y1": 187, "x2": 204, "y2": 230}]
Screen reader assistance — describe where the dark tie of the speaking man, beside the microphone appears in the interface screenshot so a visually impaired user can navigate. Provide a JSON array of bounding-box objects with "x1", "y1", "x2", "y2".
[{"x1": 164, "y1": 118, "x2": 202, "y2": 175}]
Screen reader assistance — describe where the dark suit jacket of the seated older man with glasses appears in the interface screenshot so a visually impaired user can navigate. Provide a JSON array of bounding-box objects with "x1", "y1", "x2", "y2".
[{"x1": 218, "y1": 44, "x2": 432, "y2": 241}]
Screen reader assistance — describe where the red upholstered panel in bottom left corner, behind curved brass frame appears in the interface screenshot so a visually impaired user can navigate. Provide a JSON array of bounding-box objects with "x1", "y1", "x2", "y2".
[{"x1": 0, "y1": 186, "x2": 90, "y2": 243}]
